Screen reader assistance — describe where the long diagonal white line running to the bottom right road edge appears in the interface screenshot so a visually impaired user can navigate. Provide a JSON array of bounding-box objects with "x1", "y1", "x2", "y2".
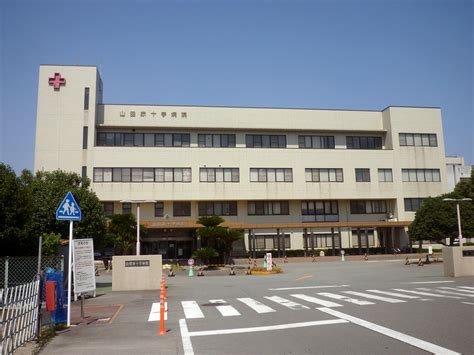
[{"x1": 318, "y1": 308, "x2": 459, "y2": 355}]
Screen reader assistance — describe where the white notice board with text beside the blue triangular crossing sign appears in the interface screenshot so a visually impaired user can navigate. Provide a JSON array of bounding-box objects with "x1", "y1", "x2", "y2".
[{"x1": 73, "y1": 239, "x2": 95, "y2": 294}]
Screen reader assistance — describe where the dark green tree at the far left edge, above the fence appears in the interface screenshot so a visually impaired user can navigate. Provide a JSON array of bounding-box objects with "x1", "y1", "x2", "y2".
[{"x1": 0, "y1": 163, "x2": 32, "y2": 256}]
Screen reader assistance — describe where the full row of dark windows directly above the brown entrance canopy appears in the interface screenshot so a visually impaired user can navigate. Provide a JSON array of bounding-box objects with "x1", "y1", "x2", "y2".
[{"x1": 103, "y1": 202, "x2": 392, "y2": 218}]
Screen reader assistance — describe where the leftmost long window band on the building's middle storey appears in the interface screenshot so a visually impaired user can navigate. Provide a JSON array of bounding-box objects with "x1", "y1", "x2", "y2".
[{"x1": 94, "y1": 168, "x2": 191, "y2": 182}]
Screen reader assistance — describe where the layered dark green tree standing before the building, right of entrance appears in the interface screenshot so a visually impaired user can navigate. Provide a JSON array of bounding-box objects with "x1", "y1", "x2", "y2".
[{"x1": 196, "y1": 216, "x2": 242, "y2": 263}]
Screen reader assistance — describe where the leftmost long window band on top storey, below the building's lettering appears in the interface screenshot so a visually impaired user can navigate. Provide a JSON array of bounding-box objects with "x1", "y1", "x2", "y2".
[{"x1": 97, "y1": 132, "x2": 190, "y2": 147}]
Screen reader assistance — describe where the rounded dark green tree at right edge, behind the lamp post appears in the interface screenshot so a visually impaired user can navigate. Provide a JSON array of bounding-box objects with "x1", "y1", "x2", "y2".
[{"x1": 408, "y1": 171, "x2": 474, "y2": 245}]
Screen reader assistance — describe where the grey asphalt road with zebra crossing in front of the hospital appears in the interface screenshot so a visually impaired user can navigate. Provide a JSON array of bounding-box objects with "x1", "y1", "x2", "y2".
[{"x1": 43, "y1": 260, "x2": 474, "y2": 355}]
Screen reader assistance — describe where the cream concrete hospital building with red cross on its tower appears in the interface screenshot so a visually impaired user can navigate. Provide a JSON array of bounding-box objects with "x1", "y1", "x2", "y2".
[{"x1": 35, "y1": 65, "x2": 448, "y2": 258}]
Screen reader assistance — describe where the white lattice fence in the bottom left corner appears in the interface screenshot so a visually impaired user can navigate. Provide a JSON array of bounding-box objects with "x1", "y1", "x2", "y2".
[{"x1": 0, "y1": 279, "x2": 40, "y2": 355}]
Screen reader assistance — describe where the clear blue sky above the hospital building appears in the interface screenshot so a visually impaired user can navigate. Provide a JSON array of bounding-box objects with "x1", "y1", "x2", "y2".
[{"x1": 0, "y1": 0, "x2": 474, "y2": 173}]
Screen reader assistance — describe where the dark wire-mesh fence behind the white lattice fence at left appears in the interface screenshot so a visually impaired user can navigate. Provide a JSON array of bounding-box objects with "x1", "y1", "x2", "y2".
[{"x1": 0, "y1": 255, "x2": 64, "y2": 289}]
